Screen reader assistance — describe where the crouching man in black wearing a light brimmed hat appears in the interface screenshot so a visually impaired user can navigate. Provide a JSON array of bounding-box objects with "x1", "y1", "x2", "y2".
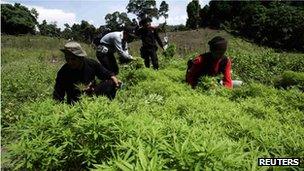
[{"x1": 53, "y1": 42, "x2": 120, "y2": 104}]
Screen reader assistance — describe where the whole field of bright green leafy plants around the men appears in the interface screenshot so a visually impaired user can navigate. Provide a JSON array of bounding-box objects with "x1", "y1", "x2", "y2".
[{"x1": 1, "y1": 30, "x2": 304, "y2": 170}]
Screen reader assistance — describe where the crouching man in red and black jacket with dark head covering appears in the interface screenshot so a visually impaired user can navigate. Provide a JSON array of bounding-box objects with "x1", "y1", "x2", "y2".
[{"x1": 186, "y1": 36, "x2": 242, "y2": 89}]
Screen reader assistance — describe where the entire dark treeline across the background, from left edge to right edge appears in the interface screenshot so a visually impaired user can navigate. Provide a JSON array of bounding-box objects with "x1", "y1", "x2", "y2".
[{"x1": 1, "y1": 0, "x2": 304, "y2": 51}]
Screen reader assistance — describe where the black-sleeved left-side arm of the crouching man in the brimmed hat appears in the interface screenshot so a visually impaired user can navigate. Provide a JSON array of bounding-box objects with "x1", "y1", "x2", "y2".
[{"x1": 53, "y1": 69, "x2": 66, "y2": 102}]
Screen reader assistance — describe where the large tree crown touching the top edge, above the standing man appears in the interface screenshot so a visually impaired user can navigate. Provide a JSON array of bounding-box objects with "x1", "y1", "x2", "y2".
[{"x1": 127, "y1": 0, "x2": 159, "y2": 19}]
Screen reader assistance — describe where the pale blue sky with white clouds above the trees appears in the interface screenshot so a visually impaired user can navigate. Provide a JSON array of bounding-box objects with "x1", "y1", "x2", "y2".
[{"x1": 1, "y1": 0, "x2": 210, "y2": 28}]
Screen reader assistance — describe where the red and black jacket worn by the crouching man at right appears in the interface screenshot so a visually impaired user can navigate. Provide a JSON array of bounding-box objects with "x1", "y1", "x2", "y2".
[{"x1": 186, "y1": 52, "x2": 232, "y2": 88}]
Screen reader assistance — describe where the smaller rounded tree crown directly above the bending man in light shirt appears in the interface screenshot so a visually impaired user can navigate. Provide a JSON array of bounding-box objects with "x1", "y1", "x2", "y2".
[{"x1": 105, "y1": 11, "x2": 132, "y2": 31}]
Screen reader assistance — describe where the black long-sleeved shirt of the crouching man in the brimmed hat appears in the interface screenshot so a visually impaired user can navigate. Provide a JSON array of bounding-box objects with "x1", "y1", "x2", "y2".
[{"x1": 53, "y1": 58, "x2": 114, "y2": 104}]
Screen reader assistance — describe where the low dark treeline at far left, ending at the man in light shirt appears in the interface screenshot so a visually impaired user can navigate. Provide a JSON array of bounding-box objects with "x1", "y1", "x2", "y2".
[{"x1": 1, "y1": 3, "x2": 114, "y2": 43}]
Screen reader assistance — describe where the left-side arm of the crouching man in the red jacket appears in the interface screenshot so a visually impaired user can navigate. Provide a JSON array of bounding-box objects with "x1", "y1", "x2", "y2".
[{"x1": 186, "y1": 56, "x2": 203, "y2": 89}]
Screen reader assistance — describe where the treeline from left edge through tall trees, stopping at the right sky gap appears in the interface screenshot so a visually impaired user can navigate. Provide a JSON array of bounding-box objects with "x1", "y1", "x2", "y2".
[{"x1": 1, "y1": 0, "x2": 169, "y2": 43}]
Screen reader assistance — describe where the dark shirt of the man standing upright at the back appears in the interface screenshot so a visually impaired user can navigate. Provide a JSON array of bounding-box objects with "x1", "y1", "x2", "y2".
[{"x1": 136, "y1": 27, "x2": 163, "y2": 48}]
